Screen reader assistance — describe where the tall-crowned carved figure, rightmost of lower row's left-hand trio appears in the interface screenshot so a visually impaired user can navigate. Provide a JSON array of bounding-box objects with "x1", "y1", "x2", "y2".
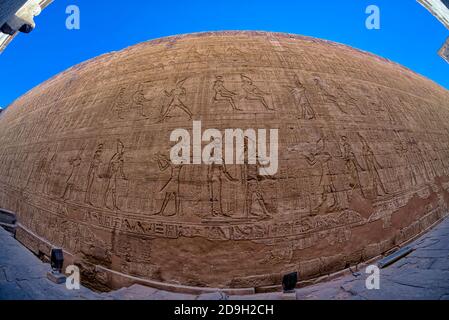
[{"x1": 103, "y1": 140, "x2": 128, "y2": 210}]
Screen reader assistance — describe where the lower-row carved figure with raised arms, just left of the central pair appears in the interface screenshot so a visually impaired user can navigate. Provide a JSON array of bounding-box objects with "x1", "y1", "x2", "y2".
[{"x1": 153, "y1": 153, "x2": 183, "y2": 217}]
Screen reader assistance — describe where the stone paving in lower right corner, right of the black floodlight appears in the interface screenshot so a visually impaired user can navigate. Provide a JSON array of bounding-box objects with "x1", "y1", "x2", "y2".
[{"x1": 296, "y1": 219, "x2": 449, "y2": 300}]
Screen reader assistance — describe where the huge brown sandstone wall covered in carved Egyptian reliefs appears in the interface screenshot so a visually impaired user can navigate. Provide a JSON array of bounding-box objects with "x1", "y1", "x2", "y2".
[{"x1": 0, "y1": 32, "x2": 449, "y2": 288}]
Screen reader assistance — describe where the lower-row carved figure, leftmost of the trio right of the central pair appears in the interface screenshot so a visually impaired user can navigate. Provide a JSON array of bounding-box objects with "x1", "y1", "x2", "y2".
[{"x1": 305, "y1": 138, "x2": 339, "y2": 213}]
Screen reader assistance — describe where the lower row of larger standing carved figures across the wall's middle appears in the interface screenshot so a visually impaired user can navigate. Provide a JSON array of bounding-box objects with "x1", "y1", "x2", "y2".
[{"x1": 0, "y1": 129, "x2": 447, "y2": 219}]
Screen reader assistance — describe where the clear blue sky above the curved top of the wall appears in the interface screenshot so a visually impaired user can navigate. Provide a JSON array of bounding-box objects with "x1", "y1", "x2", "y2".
[{"x1": 0, "y1": 0, "x2": 449, "y2": 107}]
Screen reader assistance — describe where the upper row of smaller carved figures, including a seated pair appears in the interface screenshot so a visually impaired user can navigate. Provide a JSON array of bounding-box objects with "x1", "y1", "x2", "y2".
[{"x1": 112, "y1": 74, "x2": 402, "y2": 123}]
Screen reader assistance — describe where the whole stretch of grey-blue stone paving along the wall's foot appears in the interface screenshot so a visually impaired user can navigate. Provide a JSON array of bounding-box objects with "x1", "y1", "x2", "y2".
[{"x1": 0, "y1": 219, "x2": 449, "y2": 300}]
